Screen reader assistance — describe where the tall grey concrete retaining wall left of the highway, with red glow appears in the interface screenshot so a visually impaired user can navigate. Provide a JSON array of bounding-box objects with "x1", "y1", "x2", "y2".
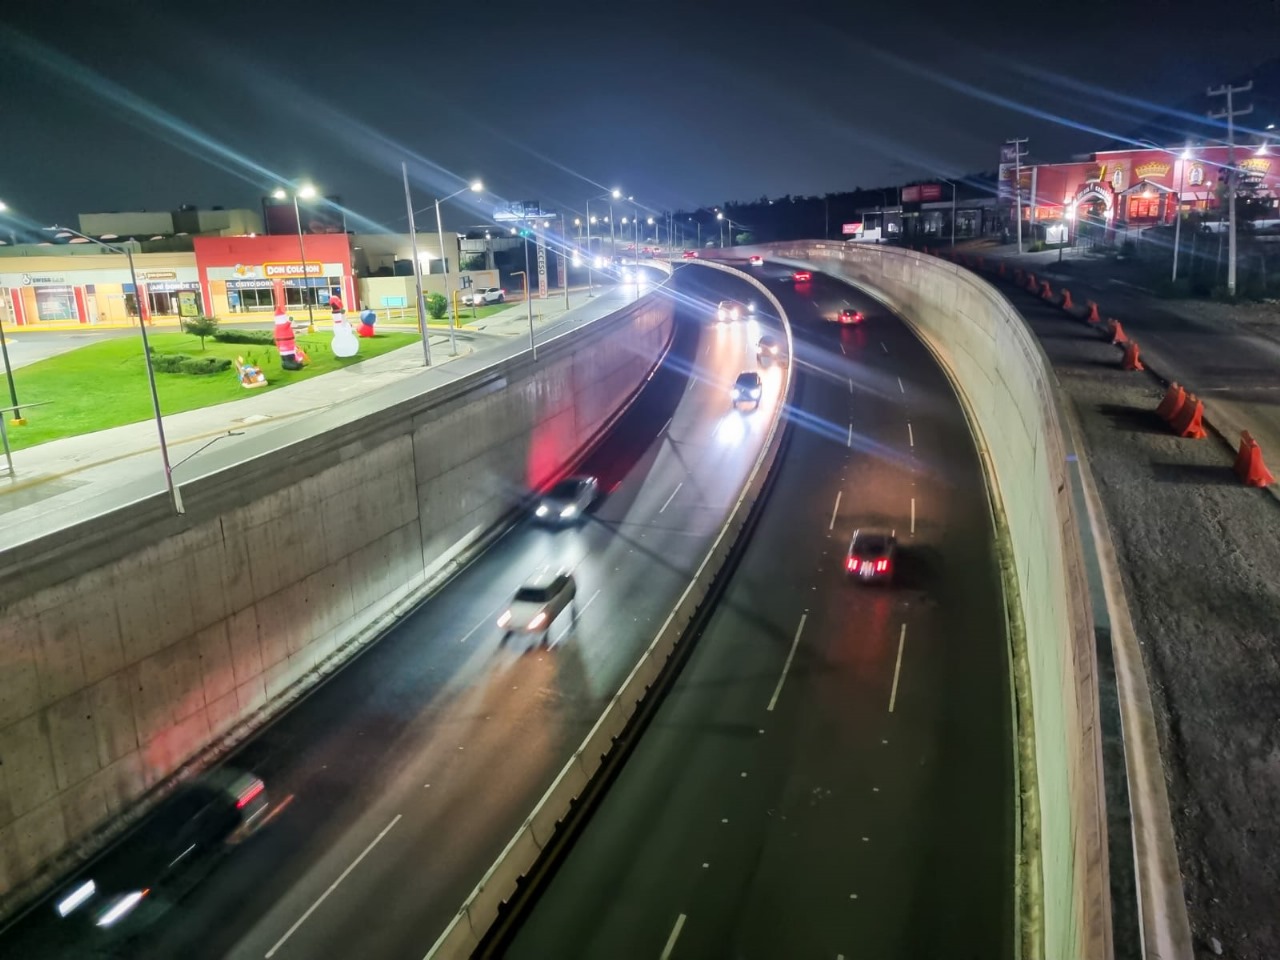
[{"x1": 0, "y1": 292, "x2": 673, "y2": 913}]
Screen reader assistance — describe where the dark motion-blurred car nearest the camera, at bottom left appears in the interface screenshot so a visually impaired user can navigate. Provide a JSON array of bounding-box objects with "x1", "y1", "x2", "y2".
[{"x1": 54, "y1": 767, "x2": 269, "y2": 940}]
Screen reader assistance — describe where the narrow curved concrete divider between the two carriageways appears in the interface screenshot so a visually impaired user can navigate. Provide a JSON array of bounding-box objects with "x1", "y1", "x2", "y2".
[{"x1": 425, "y1": 262, "x2": 795, "y2": 960}]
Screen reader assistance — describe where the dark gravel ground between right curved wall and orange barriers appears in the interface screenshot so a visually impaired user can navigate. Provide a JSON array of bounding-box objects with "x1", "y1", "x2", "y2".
[{"x1": 1005, "y1": 287, "x2": 1280, "y2": 960}]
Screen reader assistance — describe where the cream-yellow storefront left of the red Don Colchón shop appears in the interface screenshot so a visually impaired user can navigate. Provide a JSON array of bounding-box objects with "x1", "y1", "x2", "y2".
[{"x1": 0, "y1": 253, "x2": 200, "y2": 326}]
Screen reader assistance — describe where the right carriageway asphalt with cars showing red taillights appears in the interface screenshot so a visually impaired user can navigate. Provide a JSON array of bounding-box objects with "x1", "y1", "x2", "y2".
[{"x1": 495, "y1": 265, "x2": 1014, "y2": 960}]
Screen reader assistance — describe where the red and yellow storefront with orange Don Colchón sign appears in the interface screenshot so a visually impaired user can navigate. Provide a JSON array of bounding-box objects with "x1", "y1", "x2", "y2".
[{"x1": 195, "y1": 234, "x2": 356, "y2": 320}]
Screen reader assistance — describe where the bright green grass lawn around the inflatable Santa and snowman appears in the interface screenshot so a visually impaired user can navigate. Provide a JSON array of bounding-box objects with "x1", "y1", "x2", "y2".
[{"x1": 9, "y1": 332, "x2": 419, "y2": 449}]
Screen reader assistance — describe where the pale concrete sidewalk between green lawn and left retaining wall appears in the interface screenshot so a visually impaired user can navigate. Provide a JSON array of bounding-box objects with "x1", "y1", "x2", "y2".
[{"x1": 0, "y1": 288, "x2": 634, "y2": 550}]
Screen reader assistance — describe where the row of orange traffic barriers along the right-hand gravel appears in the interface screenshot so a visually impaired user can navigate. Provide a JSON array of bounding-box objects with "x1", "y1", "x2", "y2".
[{"x1": 925, "y1": 250, "x2": 1275, "y2": 486}]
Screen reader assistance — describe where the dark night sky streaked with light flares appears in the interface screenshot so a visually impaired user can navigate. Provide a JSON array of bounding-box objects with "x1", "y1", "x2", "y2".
[{"x1": 0, "y1": 0, "x2": 1280, "y2": 230}]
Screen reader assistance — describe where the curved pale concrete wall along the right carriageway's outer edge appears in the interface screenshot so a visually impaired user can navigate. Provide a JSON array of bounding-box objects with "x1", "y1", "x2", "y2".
[{"x1": 740, "y1": 242, "x2": 1112, "y2": 960}]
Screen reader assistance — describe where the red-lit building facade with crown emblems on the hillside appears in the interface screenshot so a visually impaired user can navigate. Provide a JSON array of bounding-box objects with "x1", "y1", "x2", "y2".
[{"x1": 1010, "y1": 146, "x2": 1280, "y2": 239}]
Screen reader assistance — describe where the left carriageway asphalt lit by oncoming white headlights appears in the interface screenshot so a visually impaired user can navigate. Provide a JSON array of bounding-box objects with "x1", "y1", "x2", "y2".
[{"x1": 0, "y1": 267, "x2": 781, "y2": 960}]
